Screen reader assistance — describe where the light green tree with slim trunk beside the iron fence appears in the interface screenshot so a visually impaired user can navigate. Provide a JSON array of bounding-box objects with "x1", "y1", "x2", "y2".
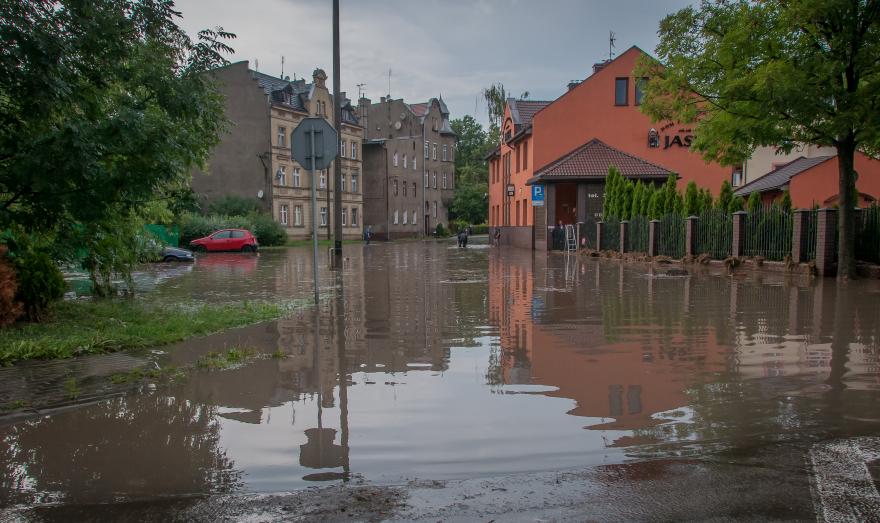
[{"x1": 636, "y1": 0, "x2": 880, "y2": 279}]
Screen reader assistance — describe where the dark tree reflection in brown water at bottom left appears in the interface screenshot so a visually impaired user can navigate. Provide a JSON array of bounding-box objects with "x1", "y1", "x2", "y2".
[{"x1": 0, "y1": 394, "x2": 241, "y2": 504}]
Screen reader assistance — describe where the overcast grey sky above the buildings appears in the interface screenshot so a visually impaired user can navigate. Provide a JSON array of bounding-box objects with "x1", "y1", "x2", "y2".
[{"x1": 176, "y1": 0, "x2": 692, "y2": 123}]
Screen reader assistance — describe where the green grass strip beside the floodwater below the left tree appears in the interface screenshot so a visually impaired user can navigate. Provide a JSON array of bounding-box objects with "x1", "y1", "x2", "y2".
[{"x1": 0, "y1": 299, "x2": 305, "y2": 365}]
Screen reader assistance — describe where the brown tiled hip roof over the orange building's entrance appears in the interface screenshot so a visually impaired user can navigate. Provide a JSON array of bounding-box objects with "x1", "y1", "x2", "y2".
[{"x1": 526, "y1": 138, "x2": 672, "y2": 185}]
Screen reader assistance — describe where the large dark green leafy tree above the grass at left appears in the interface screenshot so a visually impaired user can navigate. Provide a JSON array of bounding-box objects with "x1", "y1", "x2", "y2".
[{"x1": 0, "y1": 0, "x2": 235, "y2": 294}]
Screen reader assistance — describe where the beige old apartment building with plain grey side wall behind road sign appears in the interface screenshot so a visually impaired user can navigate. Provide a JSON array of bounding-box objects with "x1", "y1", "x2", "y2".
[{"x1": 193, "y1": 62, "x2": 364, "y2": 239}]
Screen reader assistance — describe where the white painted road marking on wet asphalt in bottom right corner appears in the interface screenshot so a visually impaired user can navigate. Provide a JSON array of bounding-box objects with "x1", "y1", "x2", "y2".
[{"x1": 809, "y1": 438, "x2": 880, "y2": 523}]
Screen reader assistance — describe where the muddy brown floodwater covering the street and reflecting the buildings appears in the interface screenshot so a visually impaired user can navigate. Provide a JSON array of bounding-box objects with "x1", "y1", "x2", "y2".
[{"x1": 0, "y1": 242, "x2": 880, "y2": 506}]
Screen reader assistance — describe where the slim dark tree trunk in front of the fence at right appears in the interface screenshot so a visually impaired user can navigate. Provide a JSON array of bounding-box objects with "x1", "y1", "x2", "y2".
[{"x1": 837, "y1": 135, "x2": 857, "y2": 280}]
